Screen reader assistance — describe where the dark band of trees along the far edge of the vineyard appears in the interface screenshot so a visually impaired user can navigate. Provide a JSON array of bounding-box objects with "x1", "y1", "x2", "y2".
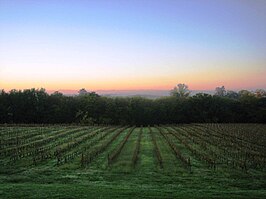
[{"x1": 0, "y1": 84, "x2": 266, "y2": 125}]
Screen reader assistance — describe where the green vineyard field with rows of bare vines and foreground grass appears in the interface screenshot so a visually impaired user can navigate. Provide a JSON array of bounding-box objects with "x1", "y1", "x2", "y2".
[{"x1": 0, "y1": 124, "x2": 266, "y2": 199}]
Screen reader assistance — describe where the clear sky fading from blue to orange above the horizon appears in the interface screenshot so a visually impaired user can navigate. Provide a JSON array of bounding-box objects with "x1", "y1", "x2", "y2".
[{"x1": 0, "y1": 0, "x2": 266, "y2": 90}]
